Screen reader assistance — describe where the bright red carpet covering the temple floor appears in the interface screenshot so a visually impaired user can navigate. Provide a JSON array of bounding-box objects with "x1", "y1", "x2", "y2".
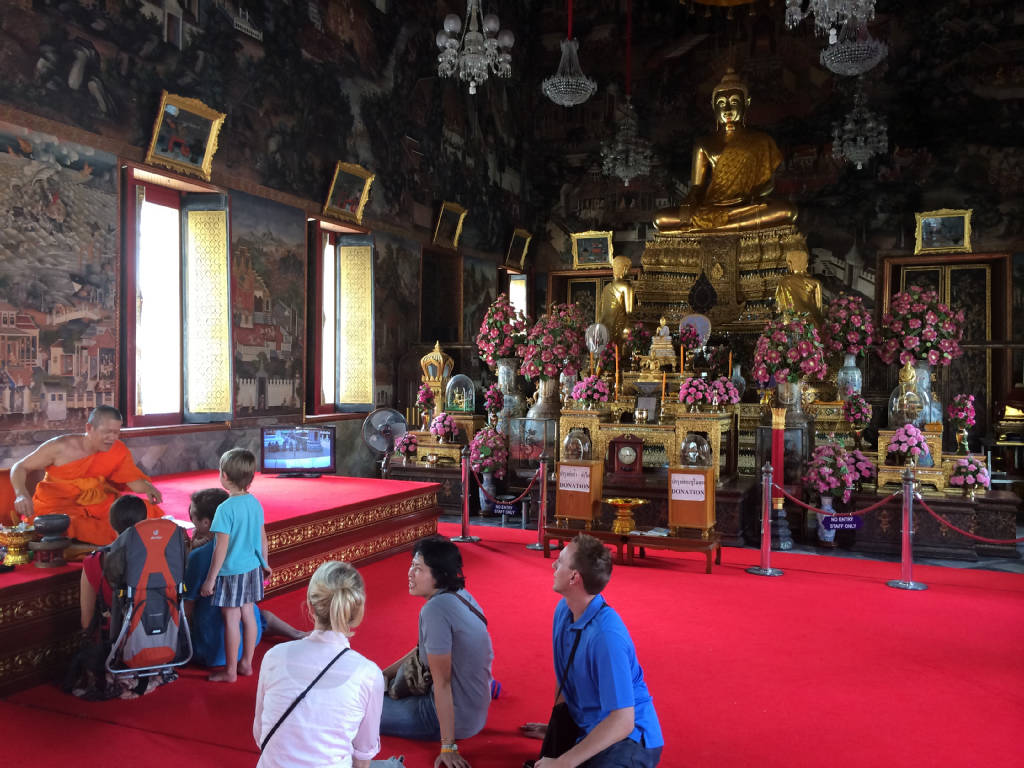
[{"x1": 0, "y1": 525, "x2": 1024, "y2": 768}]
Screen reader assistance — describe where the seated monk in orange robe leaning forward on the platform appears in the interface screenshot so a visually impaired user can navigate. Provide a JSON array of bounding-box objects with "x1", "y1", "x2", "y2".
[{"x1": 10, "y1": 406, "x2": 163, "y2": 546}]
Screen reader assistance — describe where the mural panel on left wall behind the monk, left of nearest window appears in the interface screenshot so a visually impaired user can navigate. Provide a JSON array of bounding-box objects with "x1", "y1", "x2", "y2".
[{"x1": 0, "y1": 122, "x2": 118, "y2": 429}]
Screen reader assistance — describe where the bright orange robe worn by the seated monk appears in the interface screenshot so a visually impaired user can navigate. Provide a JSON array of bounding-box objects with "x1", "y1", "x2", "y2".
[{"x1": 32, "y1": 440, "x2": 164, "y2": 545}]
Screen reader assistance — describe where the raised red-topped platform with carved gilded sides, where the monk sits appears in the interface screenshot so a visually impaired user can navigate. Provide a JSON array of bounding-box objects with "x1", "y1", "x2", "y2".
[{"x1": 0, "y1": 471, "x2": 440, "y2": 695}]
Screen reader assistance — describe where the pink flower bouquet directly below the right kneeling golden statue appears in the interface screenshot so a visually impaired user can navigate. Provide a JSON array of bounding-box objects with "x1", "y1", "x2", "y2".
[{"x1": 751, "y1": 311, "x2": 828, "y2": 385}]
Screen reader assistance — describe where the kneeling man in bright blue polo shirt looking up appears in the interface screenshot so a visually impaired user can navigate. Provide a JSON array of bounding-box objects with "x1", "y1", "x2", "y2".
[{"x1": 536, "y1": 534, "x2": 665, "y2": 768}]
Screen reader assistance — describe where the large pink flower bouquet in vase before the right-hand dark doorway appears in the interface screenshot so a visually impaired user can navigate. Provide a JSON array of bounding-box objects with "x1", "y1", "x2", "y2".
[{"x1": 878, "y1": 286, "x2": 965, "y2": 366}]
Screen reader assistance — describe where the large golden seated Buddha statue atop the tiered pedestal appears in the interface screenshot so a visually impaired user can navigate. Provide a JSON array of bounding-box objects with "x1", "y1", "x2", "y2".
[{"x1": 654, "y1": 68, "x2": 797, "y2": 232}]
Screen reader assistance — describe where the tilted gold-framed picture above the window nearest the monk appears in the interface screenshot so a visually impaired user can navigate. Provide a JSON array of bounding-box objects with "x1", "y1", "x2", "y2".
[{"x1": 145, "y1": 91, "x2": 227, "y2": 181}]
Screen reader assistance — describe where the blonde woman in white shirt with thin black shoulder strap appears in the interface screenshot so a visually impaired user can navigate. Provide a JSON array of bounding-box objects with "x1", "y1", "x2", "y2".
[{"x1": 253, "y1": 562, "x2": 384, "y2": 768}]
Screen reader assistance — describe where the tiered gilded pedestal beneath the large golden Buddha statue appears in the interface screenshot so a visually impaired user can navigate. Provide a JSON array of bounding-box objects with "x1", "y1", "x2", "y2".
[{"x1": 634, "y1": 224, "x2": 807, "y2": 332}]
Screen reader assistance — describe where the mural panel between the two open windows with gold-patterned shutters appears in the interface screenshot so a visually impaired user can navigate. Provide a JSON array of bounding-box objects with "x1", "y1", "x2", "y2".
[{"x1": 231, "y1": 193, "x2": 306, "y2": 417}]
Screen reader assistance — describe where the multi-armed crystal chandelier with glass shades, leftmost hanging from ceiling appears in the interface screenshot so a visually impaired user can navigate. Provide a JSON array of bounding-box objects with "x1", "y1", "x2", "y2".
[{"x1": 434, "y1": 0, "x2": 515, "y2": 93}]
